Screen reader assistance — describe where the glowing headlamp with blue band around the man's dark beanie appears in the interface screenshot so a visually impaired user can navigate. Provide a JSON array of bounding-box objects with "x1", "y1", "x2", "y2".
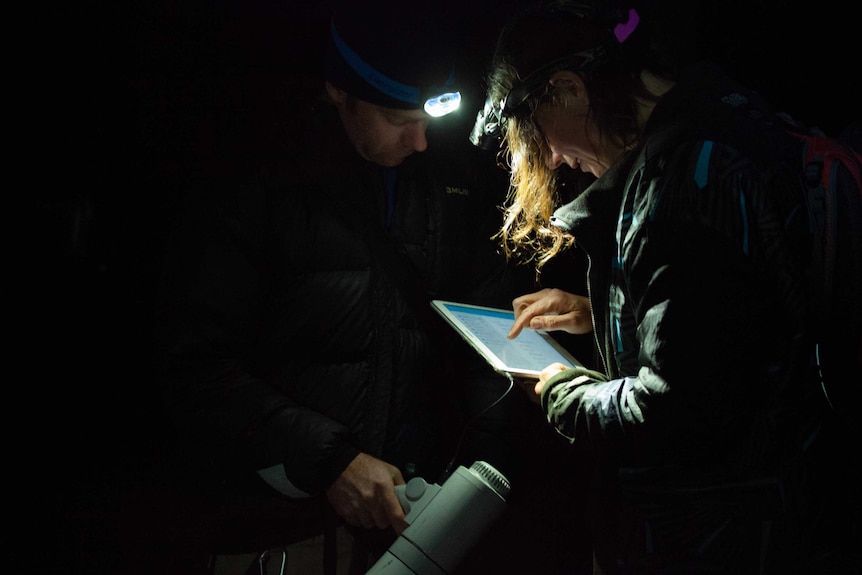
[{"x1": 330, "y1": 21, "x2": 461, "y2": 118}]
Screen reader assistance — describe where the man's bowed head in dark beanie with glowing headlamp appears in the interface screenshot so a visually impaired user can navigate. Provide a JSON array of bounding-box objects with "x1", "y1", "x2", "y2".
[{"x1": 326, "y1": 3, "x2": 463, "y2": 167}]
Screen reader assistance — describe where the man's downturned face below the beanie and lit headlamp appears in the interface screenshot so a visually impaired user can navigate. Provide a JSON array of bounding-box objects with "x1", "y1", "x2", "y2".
[{"x1": 326, "y1": 83, "x2": 430, "y2": 167}]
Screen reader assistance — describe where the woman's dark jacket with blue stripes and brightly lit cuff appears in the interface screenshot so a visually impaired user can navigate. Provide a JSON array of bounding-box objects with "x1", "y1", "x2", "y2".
[{"x1": 542, "y1": 60, "x2": 852, "y2": 573}]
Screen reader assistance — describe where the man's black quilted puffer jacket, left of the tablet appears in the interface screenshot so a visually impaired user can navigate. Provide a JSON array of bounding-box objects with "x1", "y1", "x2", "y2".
[{"x1": 154, "y1": 100, "x2": 515, "y2": 504}]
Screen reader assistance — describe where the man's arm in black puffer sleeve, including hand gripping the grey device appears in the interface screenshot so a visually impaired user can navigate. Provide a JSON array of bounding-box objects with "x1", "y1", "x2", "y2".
[{"x1": 160, "y1": 184, "x2": 410, "y2": 529}]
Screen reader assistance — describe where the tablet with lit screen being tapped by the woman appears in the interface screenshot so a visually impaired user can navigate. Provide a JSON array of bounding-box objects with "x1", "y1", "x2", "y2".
[{"x1": 431, "y1": 299, "x2": 582, "y2": 379}]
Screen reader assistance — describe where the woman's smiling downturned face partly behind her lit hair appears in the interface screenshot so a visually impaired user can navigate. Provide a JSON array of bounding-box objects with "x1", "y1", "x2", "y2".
[{"x1": 535, "y1": 103, "x2": 612, "y2": 177}]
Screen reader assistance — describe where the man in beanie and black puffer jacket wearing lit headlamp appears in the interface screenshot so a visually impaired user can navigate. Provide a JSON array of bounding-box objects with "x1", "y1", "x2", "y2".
[{"x1": 152, "y1": 2, "x2": 529, "y2": 568}]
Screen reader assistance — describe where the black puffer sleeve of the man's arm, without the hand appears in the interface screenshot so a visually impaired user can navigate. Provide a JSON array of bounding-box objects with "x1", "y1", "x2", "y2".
[{"x1": 156, "y1": 183, "x2": 358, "y2": 495}]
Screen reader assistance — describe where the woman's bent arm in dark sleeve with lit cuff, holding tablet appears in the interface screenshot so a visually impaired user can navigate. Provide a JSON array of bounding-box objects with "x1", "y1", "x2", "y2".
[{"x1": 528, "y1": 148, "x2": 808, "y2": 457}]
